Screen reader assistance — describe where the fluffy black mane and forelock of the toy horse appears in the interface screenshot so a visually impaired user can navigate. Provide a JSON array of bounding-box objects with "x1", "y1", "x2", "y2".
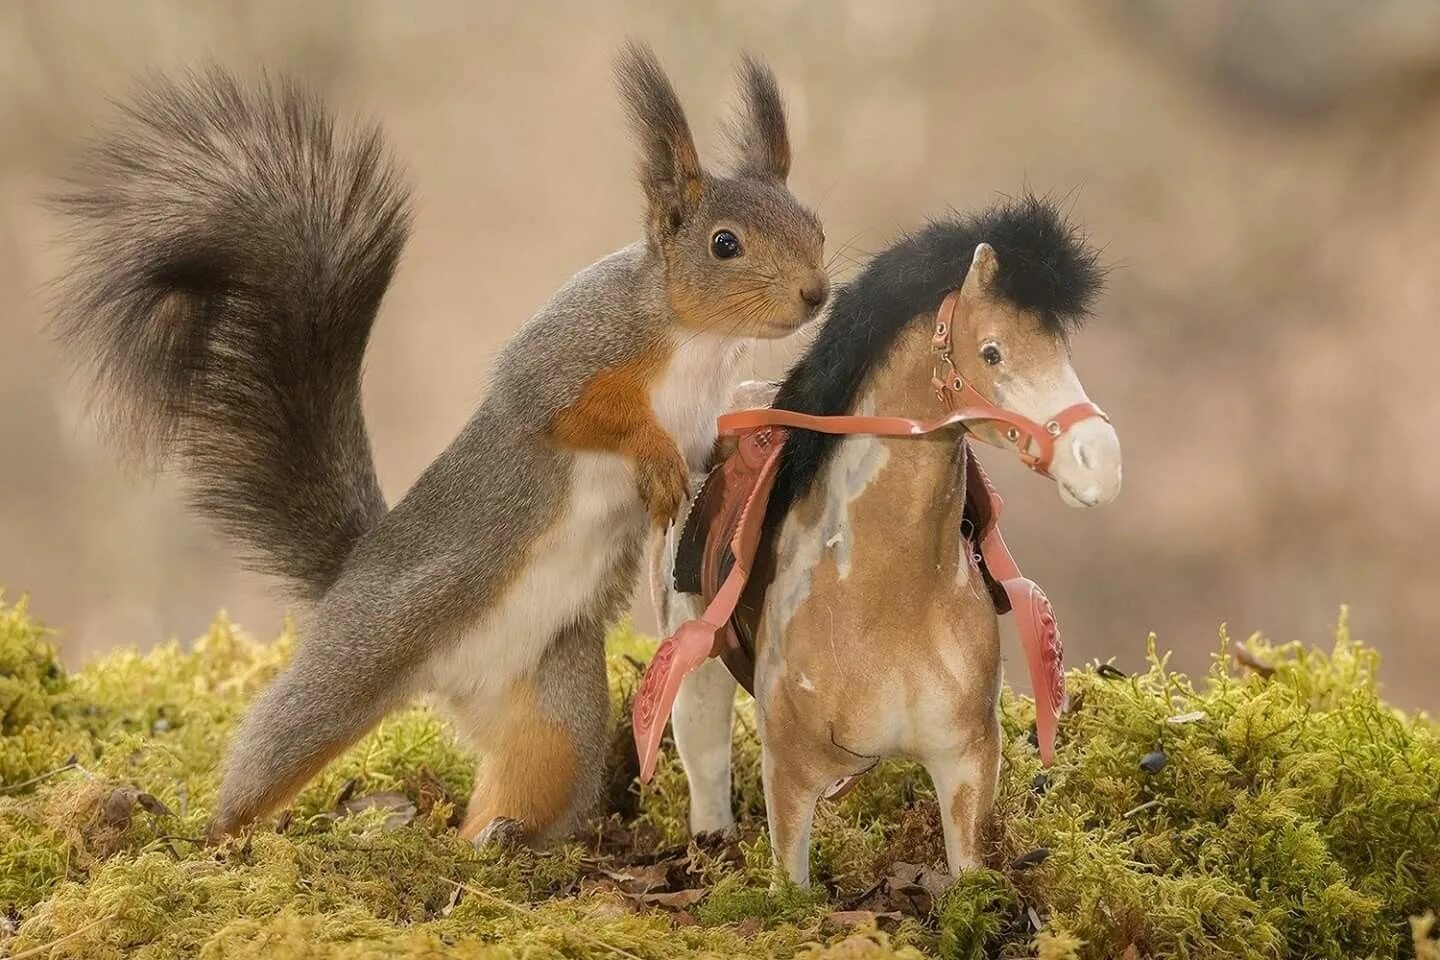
[{"x1": 766, "y1": 194, "x2": 1103, "y2": 527}]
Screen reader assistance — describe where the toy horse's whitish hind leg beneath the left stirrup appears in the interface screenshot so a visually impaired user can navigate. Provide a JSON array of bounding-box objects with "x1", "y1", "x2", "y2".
[{"x1": 675, "y1": 659, "x2": 736, "y2": 833}]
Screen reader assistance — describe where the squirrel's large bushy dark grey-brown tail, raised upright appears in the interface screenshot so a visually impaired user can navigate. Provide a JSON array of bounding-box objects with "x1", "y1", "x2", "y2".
[{"x1": 55, "y1": 71, "x2": 409, "y2": 597}]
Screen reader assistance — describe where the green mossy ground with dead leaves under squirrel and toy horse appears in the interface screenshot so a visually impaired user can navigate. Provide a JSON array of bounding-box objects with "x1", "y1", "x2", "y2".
[{"x1": 0, "y1": 603, "x2": 1440, "y2": 960}]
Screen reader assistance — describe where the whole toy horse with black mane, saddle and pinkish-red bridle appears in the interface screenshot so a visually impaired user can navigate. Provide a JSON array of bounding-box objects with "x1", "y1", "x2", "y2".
[{"x1": 635, "y1": 196, "x2": 1120, "y2": 884}]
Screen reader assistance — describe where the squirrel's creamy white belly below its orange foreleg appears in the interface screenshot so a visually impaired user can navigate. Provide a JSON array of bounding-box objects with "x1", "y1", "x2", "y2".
[{"x1": 426, "y1": 453, "x2": 647, "y2": 724}]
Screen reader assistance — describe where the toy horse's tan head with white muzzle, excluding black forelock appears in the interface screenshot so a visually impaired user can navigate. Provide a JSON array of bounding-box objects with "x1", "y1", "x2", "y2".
[{"x1": 956, "y1": 243, "x2": 1120, "y2": 507}]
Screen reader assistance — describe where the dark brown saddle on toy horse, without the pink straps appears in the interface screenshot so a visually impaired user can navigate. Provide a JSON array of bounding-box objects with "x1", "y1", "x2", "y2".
[{"x1": 674, "y1": 431, "x2": 1011, "y2": 694}]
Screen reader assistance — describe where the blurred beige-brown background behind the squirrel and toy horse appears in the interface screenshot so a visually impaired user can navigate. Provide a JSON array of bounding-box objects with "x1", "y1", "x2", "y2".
[{"x1": 0, "y1": 0, "x2": 1440, "y2": 708}]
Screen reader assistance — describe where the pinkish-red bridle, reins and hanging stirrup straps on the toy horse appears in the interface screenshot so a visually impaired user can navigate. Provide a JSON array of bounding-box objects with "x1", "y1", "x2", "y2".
[{"x1": 631, "y1": 291, "x2": 1110, "y2": 783}]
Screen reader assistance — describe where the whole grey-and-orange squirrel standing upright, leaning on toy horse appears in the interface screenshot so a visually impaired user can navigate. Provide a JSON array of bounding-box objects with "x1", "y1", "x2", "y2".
[{"x1": 55, "y1": 42, "x2": 829, "y2": 845}]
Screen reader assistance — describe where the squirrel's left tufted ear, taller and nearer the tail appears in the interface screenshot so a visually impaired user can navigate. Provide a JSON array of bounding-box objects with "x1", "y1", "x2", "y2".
[{"x1": 615, "y1": 40, "x2": 704, "y2": 236}]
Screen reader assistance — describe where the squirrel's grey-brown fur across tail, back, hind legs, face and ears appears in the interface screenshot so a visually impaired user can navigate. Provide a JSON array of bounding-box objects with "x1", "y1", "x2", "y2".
[{"x1": 56, "y1": 45, "x2": 824, "y2": 835}]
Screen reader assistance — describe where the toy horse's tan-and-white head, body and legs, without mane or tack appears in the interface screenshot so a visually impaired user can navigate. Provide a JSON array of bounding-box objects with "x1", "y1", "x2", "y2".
[{"x1": 654, "y1": 243, "x2": 1120, "y2": 884}]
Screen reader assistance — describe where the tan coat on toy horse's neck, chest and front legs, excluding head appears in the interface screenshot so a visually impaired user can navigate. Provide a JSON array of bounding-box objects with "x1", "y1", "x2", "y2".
[{"x1": 756, "y1": 322, "x2": 999, "y2": 878}]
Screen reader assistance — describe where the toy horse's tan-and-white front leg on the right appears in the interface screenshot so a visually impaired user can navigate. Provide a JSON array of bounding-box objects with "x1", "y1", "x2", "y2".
[{"x1": 924, "y1": 711, "x2": 999, "y2": 874}]
